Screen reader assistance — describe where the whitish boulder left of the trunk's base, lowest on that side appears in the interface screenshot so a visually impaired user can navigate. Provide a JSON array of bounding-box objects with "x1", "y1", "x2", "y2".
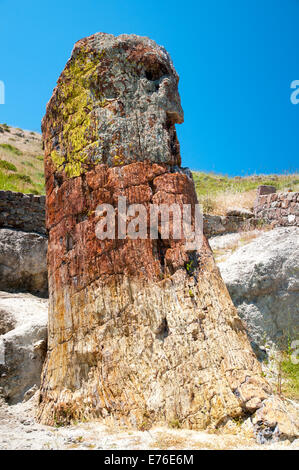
[{"x1": 0, "y1": 292, "x2": 48, "y2": 404}]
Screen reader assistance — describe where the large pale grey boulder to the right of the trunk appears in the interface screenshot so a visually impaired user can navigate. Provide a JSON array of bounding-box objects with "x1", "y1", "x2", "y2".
[{"x1": 219, "y1": 227, "x2": 299, "y2": 350}]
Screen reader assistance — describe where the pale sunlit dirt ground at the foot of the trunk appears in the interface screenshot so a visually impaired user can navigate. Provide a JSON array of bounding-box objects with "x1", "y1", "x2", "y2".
[{"x1": 0, "y1": 394, "x2": 299, "y2": 450}]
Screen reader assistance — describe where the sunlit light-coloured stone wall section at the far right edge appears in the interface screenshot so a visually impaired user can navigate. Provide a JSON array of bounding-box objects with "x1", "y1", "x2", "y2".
[{"x1": 254, "y1": 192, "x2": 299, "y2": 226}]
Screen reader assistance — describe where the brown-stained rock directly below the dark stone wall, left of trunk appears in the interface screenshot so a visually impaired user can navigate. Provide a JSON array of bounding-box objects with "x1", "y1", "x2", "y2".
[{"x1": 0, "y1": 228, "x2": 48, "y2": 296}]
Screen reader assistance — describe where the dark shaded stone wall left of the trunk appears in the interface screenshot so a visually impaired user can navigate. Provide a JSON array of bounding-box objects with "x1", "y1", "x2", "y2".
[{"x1": 0, "y1": 191, "x2": 46, "y2": 235}]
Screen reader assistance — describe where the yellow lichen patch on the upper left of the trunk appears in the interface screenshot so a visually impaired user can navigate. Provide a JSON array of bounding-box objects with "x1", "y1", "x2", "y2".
[{"x1": 51, "y1": 49, "x2": 104, "y2": 178}]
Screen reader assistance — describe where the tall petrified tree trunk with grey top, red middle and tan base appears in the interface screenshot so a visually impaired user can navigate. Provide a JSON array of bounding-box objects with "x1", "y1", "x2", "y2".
[{"x1": 39, "y1": 33, "x2": 298, "y2": 436}]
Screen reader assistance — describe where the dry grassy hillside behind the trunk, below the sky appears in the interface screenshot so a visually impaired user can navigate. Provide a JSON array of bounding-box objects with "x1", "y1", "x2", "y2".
[{"x1": 0, "y1": 124, "x2": 299, "y2": 215}]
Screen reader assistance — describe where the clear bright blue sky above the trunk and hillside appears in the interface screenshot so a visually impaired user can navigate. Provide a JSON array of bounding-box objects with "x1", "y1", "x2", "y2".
[{"x1": 0, "y1": 0, "x2": 299, "y2": 175}]
